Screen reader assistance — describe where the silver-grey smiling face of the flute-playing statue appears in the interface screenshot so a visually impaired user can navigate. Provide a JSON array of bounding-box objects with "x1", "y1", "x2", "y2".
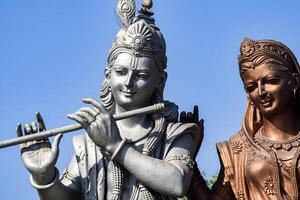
[{"x1": 109, "y1": 53, "x2": 161, "y2": 109}]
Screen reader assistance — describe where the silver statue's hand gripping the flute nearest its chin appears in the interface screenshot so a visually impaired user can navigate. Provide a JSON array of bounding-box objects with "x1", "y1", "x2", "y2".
[{"x1": 68, "y1": 98, "x2": 122, "y2": 153}]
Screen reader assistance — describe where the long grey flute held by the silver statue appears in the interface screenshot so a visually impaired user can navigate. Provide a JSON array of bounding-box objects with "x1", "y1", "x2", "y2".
[{"x1": 0, "y1": 103, "x2": 164, "y2": 149}]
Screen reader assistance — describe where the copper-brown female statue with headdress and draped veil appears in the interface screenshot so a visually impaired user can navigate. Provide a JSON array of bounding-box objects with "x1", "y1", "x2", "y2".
[{"x1": 188, "y1": 38, "x2": 300, "y2": 200}]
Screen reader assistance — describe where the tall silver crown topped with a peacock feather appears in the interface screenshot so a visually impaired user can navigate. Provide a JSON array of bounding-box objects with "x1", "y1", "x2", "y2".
[{"x1": 108, "y1": 0, "x2": 167, "y2": 71}]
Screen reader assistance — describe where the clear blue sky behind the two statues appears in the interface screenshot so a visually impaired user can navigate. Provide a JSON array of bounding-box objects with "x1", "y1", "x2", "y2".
[{"x1": 0, "y1": 0, "x2": 300, "y2": 200}]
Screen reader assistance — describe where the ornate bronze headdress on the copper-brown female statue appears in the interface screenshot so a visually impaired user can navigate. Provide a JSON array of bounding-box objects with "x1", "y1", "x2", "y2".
[{"x1": 238, "y1": 38, "x2": 300, "y2": 73}]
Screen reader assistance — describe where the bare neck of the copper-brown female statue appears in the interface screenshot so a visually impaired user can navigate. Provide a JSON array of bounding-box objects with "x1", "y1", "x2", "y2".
[{"x1": 263, "y1": 106, "x2": 300, "y2": 141}]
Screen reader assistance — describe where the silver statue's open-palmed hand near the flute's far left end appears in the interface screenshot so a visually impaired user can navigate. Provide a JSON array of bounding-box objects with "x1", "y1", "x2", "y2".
[{"x1": 17, "y1": 112, "x2": 62, "y2": 184}]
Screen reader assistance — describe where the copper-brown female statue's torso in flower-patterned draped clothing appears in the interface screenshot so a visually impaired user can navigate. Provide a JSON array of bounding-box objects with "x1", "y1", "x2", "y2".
[{"x1": 218, "y1": 131, "x2": 300, "y2": 200}]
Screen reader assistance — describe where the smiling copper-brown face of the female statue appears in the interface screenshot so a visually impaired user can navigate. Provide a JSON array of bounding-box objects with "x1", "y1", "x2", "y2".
[{"x1": 243, "y1": 64, "x2": 293, "y2": 116}]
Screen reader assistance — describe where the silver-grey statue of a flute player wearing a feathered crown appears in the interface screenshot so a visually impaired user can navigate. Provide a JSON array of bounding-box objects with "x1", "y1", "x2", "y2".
[{"x1": 17, "y1": 0, "x2": 199, "y2": 200}]
